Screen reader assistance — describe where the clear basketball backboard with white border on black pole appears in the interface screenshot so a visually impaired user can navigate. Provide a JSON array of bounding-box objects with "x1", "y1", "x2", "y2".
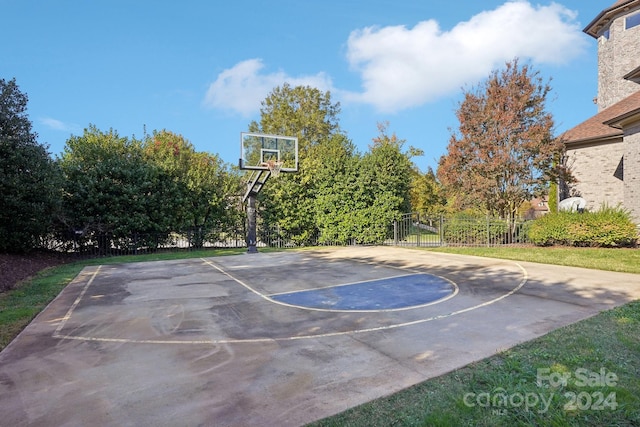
[{"x1": 239, "y1": 132, "x2": 298, "y2": 172}]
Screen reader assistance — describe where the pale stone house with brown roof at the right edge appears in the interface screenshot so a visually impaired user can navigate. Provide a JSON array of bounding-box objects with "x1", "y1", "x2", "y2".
[{"x1": 562, "y1": 0, "x2": 640, "y2": 224}]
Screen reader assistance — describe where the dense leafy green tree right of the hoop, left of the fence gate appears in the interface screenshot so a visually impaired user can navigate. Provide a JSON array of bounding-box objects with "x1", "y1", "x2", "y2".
[{"x1": 315, "y1": 123, "x2": 418, "y2": 244}]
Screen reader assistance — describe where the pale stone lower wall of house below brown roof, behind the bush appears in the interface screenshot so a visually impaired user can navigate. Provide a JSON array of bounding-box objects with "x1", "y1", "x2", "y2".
[{"x1": 567, "y1": 140, "x2": 624, "y2": 211}]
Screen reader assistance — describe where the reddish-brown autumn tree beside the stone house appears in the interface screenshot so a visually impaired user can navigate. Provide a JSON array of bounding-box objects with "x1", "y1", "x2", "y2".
[{"x1": 437, "y1": 59, "x2": 568, "y2": 217}]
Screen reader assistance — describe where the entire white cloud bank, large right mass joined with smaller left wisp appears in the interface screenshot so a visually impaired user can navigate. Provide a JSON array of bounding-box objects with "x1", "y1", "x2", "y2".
[{"x1": 203, "y1": 0, "x2": 587, "y2": 117}]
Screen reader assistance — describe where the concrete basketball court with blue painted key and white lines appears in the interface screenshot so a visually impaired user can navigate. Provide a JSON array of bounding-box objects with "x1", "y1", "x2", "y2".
[{"x1": 0, "y1": 247, "x2": 640, "y2": 426}]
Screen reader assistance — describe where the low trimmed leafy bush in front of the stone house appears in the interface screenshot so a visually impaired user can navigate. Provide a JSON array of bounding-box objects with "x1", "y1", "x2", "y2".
[{"x1": 529, "y1": 206, "x2": 638, "y2": 247}]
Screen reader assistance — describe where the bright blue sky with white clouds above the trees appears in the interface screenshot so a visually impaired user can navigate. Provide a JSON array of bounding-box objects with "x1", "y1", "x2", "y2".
[{"x1": 0, "y1": 0, "x2": 614, "y2": 170}]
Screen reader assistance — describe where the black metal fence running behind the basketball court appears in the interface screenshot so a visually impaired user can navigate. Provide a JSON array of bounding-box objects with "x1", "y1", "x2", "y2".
[{"x1": 41, "y1": 213, "x2": 529, "y2": 256}]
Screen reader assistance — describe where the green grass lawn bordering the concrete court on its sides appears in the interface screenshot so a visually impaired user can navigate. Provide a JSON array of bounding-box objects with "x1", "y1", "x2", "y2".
[{"x1": 0, "y1": 248, "x2": 640, "y2": 426}]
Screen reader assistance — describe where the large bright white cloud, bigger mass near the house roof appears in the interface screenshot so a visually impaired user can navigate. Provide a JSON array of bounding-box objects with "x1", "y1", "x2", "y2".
[{"x1": 345, "y1": 1, "x2": 586, "y2": 112}]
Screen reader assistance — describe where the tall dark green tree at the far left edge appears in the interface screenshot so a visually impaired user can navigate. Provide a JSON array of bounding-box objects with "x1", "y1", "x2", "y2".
[{"x1": 0, "y1": 79, "x2": 60, "y2": 252}]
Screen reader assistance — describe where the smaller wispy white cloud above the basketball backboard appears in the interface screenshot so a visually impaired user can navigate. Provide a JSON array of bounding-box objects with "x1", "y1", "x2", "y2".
[{"x1": 204, "y1": 59, "x2": 332, "y2": 116}]
